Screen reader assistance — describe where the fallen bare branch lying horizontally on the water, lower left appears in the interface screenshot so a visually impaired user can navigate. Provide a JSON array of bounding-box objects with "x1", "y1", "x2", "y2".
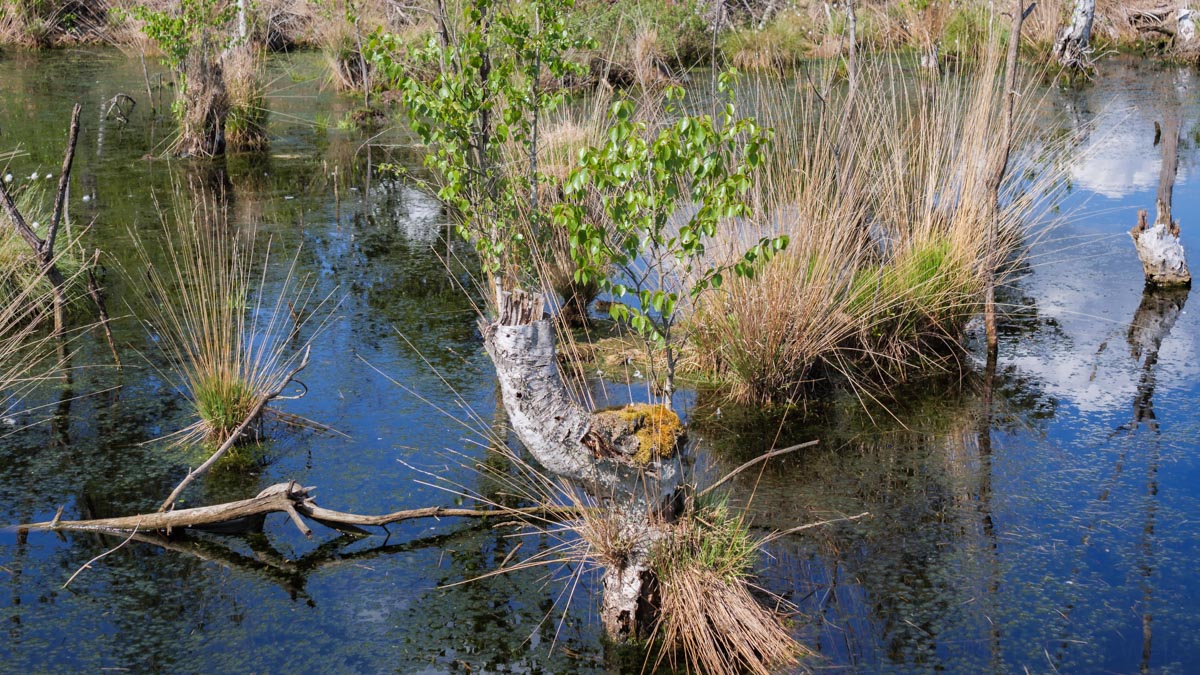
[{"x1": 14, "y1": 480, "x2": 581, "y2": 537}]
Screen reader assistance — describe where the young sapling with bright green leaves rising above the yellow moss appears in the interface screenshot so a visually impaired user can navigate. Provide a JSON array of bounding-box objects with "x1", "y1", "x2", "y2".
[{"x1": 556, "y1": 71, "x2": 787, "y2": 400}]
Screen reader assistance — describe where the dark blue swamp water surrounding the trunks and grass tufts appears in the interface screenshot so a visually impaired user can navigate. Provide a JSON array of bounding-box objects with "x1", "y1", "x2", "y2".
[{"x1": 0, "y1": 50, "x2": 1200, "y2": 673}]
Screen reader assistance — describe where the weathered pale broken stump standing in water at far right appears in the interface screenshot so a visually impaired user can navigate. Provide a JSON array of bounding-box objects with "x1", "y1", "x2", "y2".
[{"x1": 1129, "y1": 114, "x2": 1192, "y2": 286}]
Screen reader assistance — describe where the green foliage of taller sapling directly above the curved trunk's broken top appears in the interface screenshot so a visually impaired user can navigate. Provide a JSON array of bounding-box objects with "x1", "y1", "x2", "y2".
[{"x1": 367, "y1": 0, "x2": 590, "y2": 274}]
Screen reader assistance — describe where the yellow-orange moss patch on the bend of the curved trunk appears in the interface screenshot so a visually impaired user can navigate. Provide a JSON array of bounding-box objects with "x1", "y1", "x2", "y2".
[{"x1": 583, "y1": 404, "x2": 686, "y2": 466}]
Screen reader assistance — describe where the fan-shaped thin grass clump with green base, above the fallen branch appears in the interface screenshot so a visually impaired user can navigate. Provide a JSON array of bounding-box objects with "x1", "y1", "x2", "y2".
[{"x1": 130, "y1": 186, "x2": 330, "y2": 447}]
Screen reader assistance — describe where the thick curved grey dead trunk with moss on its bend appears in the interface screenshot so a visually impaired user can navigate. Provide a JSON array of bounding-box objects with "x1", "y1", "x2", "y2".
[{"x1": 482, "y1": 285, "x2": 682, "y2": 641}]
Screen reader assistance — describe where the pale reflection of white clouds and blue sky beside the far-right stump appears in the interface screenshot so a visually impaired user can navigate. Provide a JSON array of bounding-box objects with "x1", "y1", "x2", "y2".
[{"x1": 1009, "y1": 64, "x2": 1200, "y2": 412}]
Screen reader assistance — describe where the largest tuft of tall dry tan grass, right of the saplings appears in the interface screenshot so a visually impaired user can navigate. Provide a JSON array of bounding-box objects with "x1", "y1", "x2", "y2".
[{"x1": 690, "y1": 48, "x2": 1061, "y2": 401}]
